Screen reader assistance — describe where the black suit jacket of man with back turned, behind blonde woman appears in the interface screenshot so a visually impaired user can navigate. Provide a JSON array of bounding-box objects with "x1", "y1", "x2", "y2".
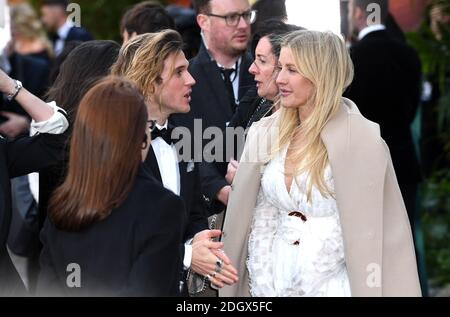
[{"x1": 345, "y1": 31, "x2": 421, "y2": 185}]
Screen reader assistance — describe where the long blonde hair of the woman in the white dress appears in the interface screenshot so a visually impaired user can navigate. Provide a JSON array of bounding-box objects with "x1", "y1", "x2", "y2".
[{"x1": 272, "y1": 30, "x2": 353, "y2": 201}]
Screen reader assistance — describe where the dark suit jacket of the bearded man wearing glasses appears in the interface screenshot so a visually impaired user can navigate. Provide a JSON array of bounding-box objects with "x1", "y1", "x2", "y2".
[{"x1": 175, "y1": 44, "x2": 255, "y2": 212}]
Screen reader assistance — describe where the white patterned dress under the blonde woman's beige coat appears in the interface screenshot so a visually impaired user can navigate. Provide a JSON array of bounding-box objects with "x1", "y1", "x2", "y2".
[{"x1": 247, "y1": 149, "x2": 351, "y2": 297}]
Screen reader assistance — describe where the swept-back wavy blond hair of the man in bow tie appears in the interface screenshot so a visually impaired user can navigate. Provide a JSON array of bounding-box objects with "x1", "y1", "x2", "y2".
[{"x1": 111, "y1": 30, "x2": 183, "y2": 101}]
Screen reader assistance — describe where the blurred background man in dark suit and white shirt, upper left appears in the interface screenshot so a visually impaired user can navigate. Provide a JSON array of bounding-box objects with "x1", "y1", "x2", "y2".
[{"x1": 41, "y1": 0, "x2": 93, "y2": 56}]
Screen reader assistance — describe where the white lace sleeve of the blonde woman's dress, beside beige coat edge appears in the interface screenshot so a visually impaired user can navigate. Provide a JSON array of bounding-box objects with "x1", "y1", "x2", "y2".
[{"x1": 247, "y1": 188, "x2": 278, "y2": 297}]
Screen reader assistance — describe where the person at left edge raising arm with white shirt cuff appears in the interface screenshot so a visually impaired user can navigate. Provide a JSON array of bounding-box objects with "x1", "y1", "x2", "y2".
[{"x1": 0, "y1": 65, "x2": 68, "y2": 296}]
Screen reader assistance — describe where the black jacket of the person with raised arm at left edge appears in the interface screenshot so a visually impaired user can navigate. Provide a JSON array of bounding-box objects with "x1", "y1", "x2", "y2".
[{"x1": 0, "y1": 134, "x2": 67, "y2": 296}]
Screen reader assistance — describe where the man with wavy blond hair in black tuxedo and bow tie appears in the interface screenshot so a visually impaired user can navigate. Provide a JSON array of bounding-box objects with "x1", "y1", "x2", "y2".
[{"x1": 112, "y1": 30, "x2": 236, "y2": 295}]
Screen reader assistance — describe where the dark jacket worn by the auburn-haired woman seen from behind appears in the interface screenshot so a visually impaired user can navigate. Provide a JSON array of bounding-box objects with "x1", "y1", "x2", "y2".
[{"x1": 37, "y1": 166, "x2": 185, "y2": 297}]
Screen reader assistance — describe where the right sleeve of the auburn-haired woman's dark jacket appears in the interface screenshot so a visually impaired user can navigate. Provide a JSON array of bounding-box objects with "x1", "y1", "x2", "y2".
[{"x1": 122, "y1": 195, "x2": 185, "y2": 297}]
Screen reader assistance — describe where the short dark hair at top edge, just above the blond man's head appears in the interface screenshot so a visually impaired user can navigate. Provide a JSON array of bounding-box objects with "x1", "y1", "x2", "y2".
[{"x1": 120, "y1": 1, "x2": 176, "y2": 35}]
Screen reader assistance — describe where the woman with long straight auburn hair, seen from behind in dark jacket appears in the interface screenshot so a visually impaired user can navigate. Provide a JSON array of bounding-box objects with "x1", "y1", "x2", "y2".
[{"x1": 38, "y1": 77, "x2": 185, "y2": 296}]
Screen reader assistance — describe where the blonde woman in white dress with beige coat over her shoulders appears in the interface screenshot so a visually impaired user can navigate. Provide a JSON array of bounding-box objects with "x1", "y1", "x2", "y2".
[{"x1": 219, "y1": 31, "x2": 420, "y2": 296}]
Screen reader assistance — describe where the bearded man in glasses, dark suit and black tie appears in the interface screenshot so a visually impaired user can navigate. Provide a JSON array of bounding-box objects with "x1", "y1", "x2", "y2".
[{"x1": 182, "y1": 0, "x2": 256, "y2": 215}]
